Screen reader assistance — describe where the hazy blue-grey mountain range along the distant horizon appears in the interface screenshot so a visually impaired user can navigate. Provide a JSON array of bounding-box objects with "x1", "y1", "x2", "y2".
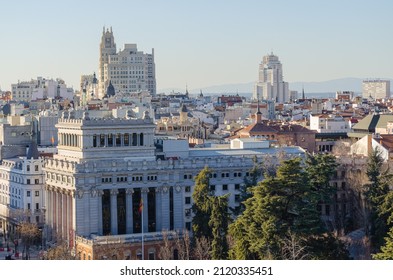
[{"x1": 158, "y1": 78, "x2": 393, "y2": 96}]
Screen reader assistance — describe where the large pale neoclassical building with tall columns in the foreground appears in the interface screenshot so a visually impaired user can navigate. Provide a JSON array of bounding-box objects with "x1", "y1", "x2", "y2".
[{"x1": 44, "y1": 112, "x2": 304, "y2": 259}]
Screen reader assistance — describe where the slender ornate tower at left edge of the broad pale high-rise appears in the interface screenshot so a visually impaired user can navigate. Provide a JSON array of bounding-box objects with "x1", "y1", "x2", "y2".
[{"x1": 98, "y1": 26, "x2": 116, "y2": 97}]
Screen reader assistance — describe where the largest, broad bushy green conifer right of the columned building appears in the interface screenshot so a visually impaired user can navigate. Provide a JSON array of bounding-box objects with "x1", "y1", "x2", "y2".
[{"x1": 229, "y1": 158, "x2": 315, "y2": 259}]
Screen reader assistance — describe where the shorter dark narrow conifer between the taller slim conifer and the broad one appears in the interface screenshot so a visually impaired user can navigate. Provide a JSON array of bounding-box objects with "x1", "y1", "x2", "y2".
[{"x1": 209, "y1": 194, "x2": 229, "y2": 260}]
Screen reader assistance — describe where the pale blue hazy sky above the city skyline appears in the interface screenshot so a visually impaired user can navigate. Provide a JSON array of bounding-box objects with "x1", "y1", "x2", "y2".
[{"x1": 0, "y1": 0, "x2": 393, "y2": 90}]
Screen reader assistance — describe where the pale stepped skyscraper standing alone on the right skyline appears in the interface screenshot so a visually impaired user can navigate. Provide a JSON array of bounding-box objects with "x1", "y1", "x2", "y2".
[{"x1": 253, "y1": 53, "x2": 290, "y2": 103}]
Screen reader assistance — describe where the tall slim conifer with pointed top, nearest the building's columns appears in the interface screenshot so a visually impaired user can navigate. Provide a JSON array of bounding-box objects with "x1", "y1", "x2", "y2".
[{"x1": 192, "y1": 166, "x2": 213, "y2": 239}]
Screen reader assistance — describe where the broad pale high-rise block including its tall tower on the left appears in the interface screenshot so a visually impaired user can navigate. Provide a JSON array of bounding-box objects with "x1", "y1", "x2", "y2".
[{"x1": 98, "y1": 27, "x2": 156, "y2": 98}]
